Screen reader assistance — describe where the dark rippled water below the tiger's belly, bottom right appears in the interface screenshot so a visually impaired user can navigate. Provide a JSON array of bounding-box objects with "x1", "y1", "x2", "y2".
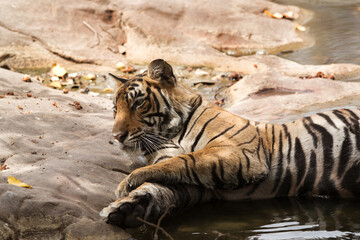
[{"x1": 132, "y1": 197, "x2": 360, "y2": 240}]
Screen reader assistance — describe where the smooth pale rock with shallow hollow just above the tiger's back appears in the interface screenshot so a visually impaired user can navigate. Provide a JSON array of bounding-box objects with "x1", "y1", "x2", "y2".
[{"x1": 225, "y1": 70, "x2": 360, "y2": 122}]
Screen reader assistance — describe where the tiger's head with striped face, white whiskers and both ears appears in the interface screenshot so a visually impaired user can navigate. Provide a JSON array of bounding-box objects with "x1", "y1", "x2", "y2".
[{"x1": 112, "y1": 59, "x2": 197, "y2": 153}]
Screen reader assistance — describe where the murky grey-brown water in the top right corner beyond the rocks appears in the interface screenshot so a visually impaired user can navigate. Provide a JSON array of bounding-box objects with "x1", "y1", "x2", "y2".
[{"x1": 273, "y1": 0, "x2": 360, "y2": 64}]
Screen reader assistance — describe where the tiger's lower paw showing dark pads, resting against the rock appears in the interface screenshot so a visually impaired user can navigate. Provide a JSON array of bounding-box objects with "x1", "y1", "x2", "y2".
[{"x1": 100, "y1": 194, "x2": 151, "y2": 228}]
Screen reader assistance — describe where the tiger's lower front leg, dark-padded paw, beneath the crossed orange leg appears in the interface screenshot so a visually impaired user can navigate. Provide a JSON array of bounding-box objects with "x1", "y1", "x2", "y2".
[{"x1": 100, "y1": 183, "x2": 213, "y2": 228}]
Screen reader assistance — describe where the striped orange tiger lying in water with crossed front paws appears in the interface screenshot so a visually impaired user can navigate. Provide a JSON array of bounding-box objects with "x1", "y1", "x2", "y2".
[{"x1": 100, "y1": 59, "x2": 360, "y2": 228}]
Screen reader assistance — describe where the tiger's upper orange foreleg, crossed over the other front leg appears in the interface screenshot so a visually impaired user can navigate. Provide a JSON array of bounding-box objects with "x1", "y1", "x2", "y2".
[{"x1": 116, "y1": 148, "x2": 269, "y2": 197}]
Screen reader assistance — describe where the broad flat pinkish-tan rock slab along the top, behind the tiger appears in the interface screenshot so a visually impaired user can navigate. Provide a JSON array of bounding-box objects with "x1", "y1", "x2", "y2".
[{"x1": 0, "y1": 0, "x2": 312, "y2": 70}]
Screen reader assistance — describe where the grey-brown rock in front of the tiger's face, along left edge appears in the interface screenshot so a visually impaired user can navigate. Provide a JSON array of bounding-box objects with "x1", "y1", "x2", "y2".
[{"x1": 0, "y1": 69, "x2": 139, "y2": 239}]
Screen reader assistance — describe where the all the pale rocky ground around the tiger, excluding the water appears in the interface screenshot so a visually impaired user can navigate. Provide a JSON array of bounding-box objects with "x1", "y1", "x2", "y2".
[{"x1": 0, "y1": 0, "x2": 360, "y2": 239}]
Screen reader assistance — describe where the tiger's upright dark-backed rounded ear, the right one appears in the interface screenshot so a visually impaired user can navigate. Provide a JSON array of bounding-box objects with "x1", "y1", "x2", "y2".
[{"x1": 148, "y1": 59, "x2": 176, "y2": 87}]
